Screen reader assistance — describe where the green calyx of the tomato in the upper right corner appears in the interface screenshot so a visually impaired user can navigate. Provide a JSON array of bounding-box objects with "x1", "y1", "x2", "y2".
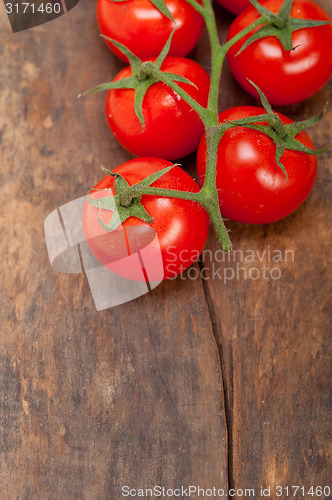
[{"x1": 236, "y1": 0, "x2": 330, "y2": 55}]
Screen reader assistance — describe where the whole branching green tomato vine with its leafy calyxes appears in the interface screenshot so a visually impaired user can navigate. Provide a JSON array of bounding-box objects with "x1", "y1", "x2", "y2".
[{"x1": 86, "y1": 0, "x2": 328, "y2": 252}]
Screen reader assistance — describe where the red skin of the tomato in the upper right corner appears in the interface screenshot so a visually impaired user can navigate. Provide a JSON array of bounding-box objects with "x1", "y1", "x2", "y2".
[{"x1": 227, "y1": 0, "x2": 332, "y2": 105}]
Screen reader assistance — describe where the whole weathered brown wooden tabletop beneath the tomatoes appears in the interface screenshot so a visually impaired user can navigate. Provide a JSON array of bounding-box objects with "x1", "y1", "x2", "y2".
[{"x1": 0, "y1": 0, "x2": 332, "y2": 500}]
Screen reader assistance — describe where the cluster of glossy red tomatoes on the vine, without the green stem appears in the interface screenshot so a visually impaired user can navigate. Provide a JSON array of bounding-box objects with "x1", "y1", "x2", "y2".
[{"x1": 83, "y1": 0, "x2": 332, "y2": 279}]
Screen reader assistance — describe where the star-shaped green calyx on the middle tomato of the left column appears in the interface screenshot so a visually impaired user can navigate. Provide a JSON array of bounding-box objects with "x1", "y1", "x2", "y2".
[{"x1": 79, "y1": 29, "x2": 194, "y2": 130}]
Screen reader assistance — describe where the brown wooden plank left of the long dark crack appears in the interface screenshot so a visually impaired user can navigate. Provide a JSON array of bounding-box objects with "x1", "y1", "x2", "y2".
[{"x1": 0, "y1": 0, "x2": 227, "y2": 500}]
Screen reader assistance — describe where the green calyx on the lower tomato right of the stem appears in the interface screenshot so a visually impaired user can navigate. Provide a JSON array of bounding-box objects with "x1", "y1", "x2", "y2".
[{"x1": 224, "y1": 80, "x2": 326, "y2": 182}]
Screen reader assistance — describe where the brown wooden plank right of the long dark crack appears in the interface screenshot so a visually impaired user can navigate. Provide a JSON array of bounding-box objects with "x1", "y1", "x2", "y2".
[{"x1": 197, "y1": 0, "x2": 332, "y2": 499}]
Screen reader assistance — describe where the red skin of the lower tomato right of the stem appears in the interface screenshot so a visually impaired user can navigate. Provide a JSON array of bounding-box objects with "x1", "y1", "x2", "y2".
[{"x1": 197, "y1": 106, "x2": 317, "y2": 224}]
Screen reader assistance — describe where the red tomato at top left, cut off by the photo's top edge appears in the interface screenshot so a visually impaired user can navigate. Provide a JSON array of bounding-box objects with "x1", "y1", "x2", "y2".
[{"x1": 97, "y1": 0, "x2": 204, "y2": 61}]
